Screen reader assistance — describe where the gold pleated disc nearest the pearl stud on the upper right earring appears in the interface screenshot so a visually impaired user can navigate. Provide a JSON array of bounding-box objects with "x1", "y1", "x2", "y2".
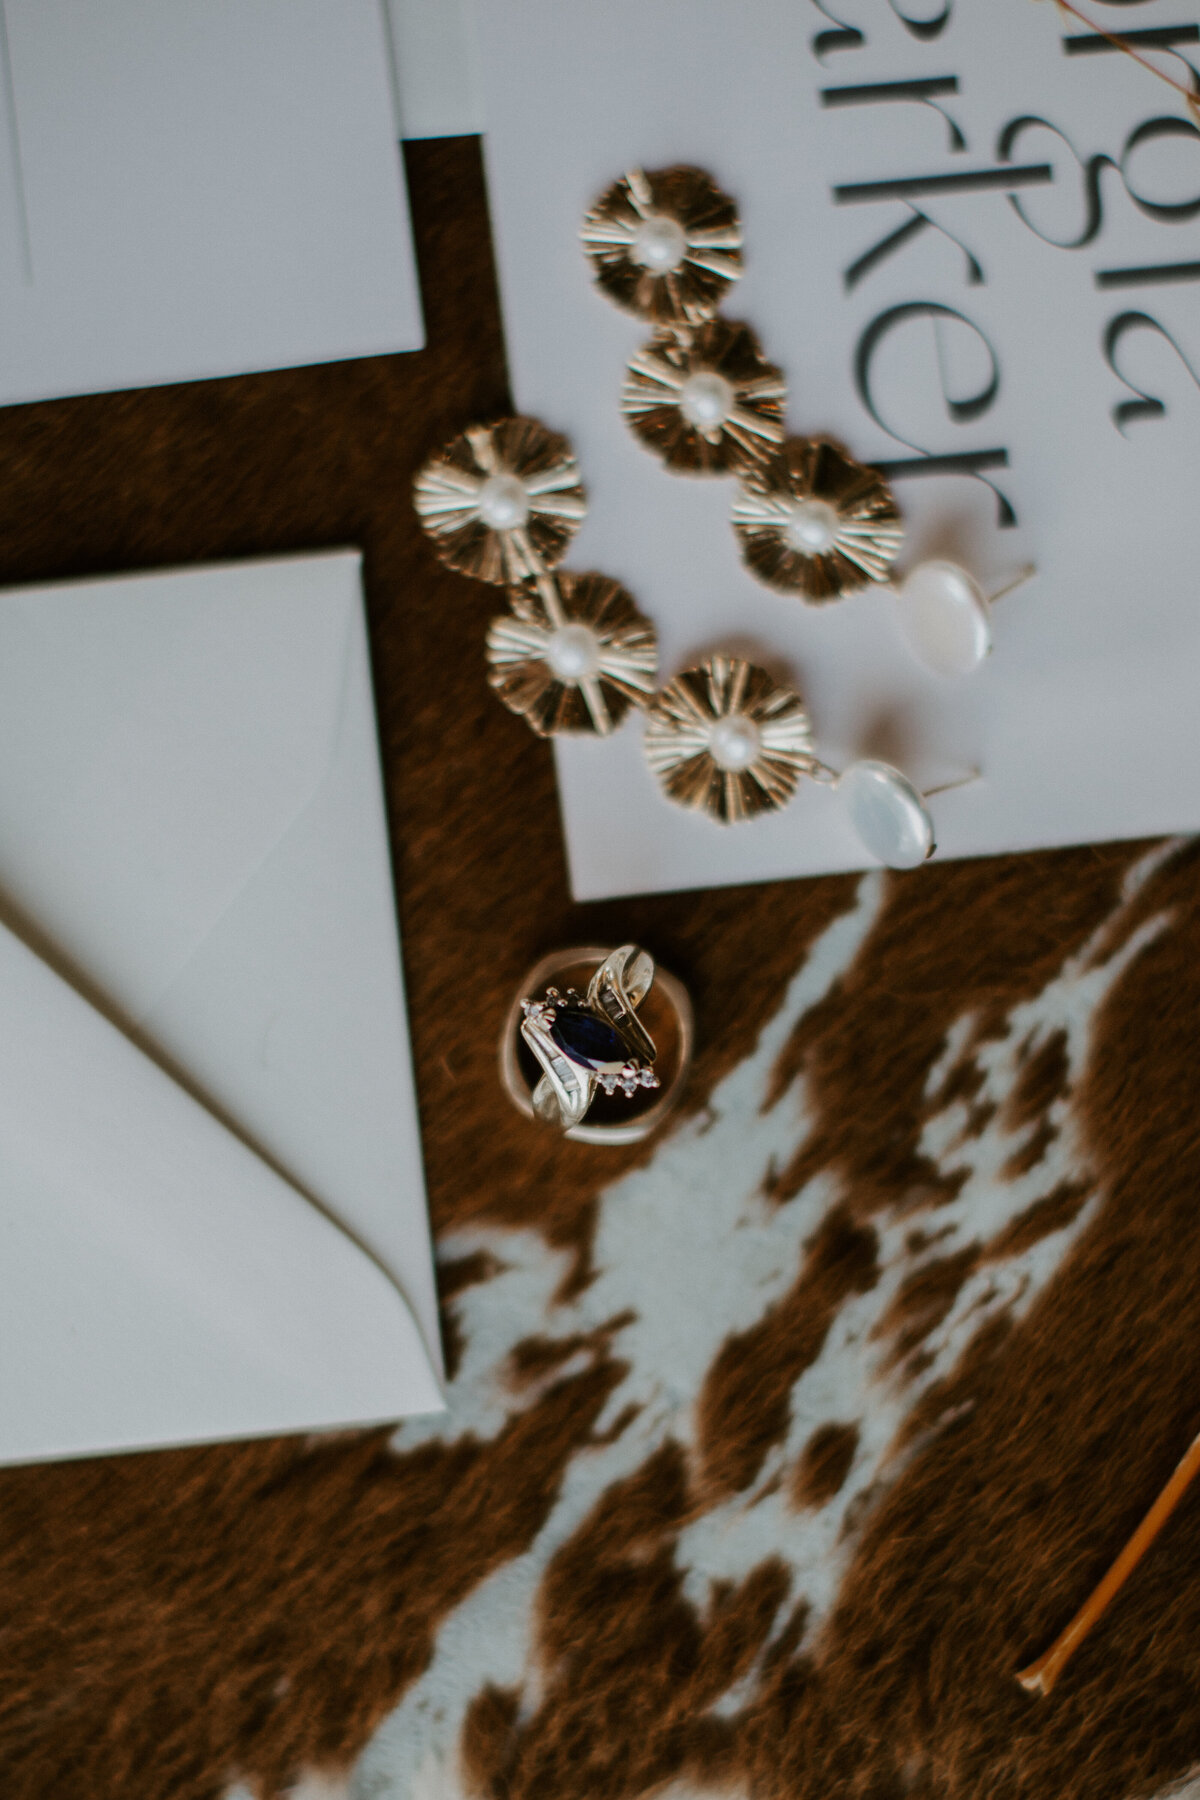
[{"x1": 732, "y1": 437, "x2": 905, "y2": 601}]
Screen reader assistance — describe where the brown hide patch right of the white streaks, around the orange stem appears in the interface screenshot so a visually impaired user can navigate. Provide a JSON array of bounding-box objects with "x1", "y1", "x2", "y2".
[{"x1": 741, "y1": 848, "x2": 1200, "y2": 1800}]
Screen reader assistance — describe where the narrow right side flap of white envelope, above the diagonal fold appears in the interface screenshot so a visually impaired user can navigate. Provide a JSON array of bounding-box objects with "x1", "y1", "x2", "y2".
[{"x1": 137, "y1": 583, "x2": 439, "y2": 1366}]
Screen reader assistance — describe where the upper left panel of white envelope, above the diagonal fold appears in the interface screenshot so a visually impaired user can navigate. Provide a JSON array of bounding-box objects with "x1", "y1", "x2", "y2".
[{"x1": 0, "y1": 553, "x2": 360, "y2": 1017}]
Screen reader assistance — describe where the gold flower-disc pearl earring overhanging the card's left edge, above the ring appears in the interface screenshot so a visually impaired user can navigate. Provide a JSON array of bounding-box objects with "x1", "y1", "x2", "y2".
[{"x1": 414, "y1": 418, "x2": 957, "y2": 869}]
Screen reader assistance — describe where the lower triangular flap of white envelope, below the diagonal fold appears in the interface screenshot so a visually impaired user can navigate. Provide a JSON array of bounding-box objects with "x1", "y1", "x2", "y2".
[{"x1": 0, "y1": 907, "x2": 443, "y2": 1462}]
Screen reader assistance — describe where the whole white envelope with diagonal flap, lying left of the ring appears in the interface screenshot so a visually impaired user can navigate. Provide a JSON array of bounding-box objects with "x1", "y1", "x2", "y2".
[{"x1": 0, "y1": 551, "x2": 443, "y2": 1462}]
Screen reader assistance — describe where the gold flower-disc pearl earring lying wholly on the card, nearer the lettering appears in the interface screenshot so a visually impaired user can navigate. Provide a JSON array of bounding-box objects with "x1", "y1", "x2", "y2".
[{"x1": 579, "y1": 166, "x2": 1033, "y2": 675}]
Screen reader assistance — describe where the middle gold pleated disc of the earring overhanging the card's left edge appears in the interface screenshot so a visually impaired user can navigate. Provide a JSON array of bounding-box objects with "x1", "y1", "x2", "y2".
[{"x1": 488, "y1": 571, "x2": 658, "y2": 738}]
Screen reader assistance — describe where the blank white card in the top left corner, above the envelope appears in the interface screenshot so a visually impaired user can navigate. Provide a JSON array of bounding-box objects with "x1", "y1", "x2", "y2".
[{"x1": 0, "y1": 0, "x2": 423, "y2": 403}]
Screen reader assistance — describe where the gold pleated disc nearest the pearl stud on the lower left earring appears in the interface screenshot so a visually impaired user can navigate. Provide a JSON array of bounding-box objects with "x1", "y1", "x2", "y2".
[{"x1": 646, "y1": 657, "x2": 820, "y2": 824}]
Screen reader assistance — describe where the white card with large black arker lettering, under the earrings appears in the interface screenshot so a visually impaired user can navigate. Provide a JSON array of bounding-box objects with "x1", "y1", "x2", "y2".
[{"x1": 479, "y1": 0, "x2": 1200, "y2": 898}]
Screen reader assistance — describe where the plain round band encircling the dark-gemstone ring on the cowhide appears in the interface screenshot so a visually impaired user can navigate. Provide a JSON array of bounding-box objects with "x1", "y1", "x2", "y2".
[{"x1": 498, "y1": 945, "x2": 693, "y2": 1145}]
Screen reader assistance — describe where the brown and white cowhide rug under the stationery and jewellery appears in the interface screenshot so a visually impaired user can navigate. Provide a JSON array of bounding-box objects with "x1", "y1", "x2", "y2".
[{"x1": 0, "y1": 142, "x2": 1200, "y2": 1800}]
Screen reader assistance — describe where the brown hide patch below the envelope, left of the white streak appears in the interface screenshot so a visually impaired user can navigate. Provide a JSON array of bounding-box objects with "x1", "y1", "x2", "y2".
[{"x1": 0, "y1": 1368, "x2": 617, "y2": 1800}]
